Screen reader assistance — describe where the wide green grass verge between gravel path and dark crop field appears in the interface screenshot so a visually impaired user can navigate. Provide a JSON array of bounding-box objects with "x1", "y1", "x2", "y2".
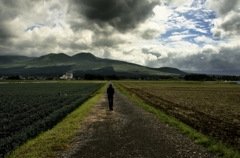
[{"x1": 6, "y1": 84, "x2": 106, "y2": 158}]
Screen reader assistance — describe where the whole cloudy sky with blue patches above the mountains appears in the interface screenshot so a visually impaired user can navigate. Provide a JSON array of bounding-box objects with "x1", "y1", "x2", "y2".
[{"x1": 0, "y1": 0, "x2": 240, "y2": 75}]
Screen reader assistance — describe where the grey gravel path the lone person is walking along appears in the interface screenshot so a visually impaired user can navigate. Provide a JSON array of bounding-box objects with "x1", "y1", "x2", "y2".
[{"x1": 60, "y1": 88, "x2": 217, "y2": 158}]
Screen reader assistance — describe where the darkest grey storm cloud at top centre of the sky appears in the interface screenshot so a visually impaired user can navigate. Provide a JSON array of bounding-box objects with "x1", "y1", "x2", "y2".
[{"x1": 70, "y1": 0, "x2": 159, "y2": 32}]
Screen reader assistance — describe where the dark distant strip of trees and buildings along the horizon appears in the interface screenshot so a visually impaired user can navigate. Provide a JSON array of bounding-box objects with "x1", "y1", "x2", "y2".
[{"x1": 0, "y1": 72, "x2": 240, "y2": 84}]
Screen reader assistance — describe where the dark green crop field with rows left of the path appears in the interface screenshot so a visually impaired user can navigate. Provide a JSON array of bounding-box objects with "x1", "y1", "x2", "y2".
[{"x1": 0, "y1": 82, "x2": 103, "y2": 157}]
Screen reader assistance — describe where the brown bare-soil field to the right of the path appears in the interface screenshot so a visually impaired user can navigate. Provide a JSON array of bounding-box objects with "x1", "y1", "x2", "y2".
[{"x1": 119, "y1": 82, "x2": 240, "y2": 150}]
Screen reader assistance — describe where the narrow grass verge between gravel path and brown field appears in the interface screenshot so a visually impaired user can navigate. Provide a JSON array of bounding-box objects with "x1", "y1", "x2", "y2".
[{"x1": 114, "y1": 83, "x2": 240, "y2": 158}]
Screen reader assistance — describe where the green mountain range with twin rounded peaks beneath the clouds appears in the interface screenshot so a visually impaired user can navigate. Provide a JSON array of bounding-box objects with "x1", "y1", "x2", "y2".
[{"x1": 0, "y1": 52, "x2": 187, "y2": 77}]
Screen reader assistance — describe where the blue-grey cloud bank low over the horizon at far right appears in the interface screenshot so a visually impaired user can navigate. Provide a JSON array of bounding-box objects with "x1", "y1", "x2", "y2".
[{"x1": 158, "y1": 47, "x2": 240, "y2": 70}]
